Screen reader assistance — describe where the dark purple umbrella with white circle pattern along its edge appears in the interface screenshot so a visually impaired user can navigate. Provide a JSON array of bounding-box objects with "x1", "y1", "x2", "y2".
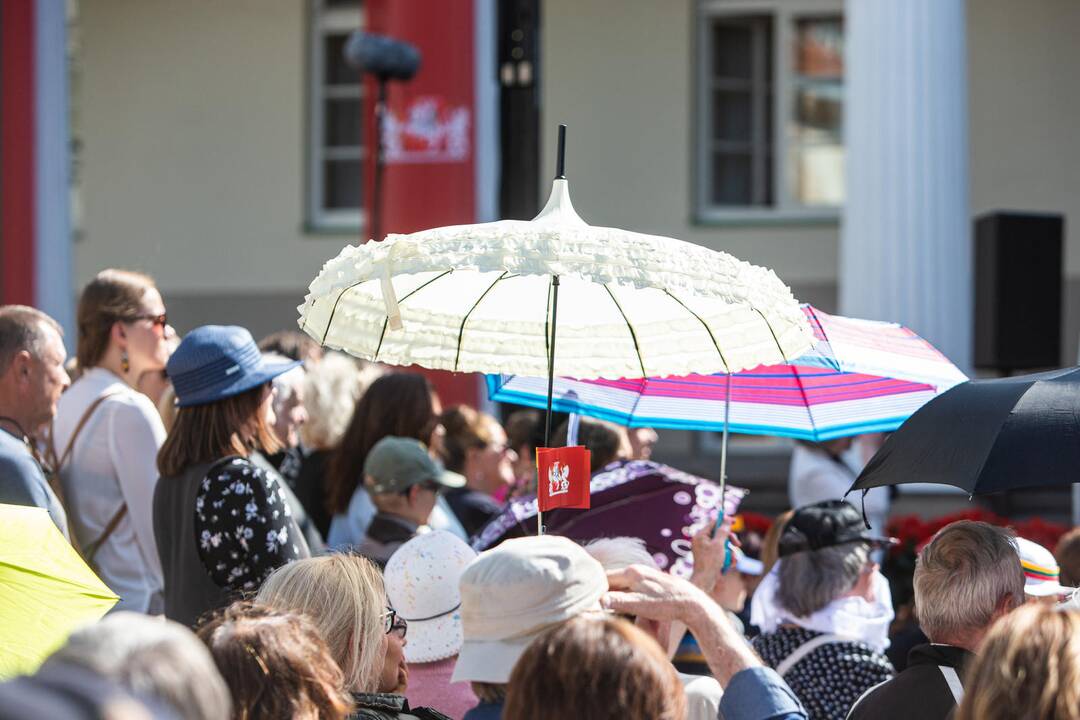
[{"x1": 473, "y1": 460, "x2": 746, "y2": 576}]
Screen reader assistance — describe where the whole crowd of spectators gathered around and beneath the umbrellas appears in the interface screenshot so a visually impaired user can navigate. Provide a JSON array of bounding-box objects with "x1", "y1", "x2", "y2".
[{"x1": 0, "y1": 270, "x2": 1080, "y2": 720}]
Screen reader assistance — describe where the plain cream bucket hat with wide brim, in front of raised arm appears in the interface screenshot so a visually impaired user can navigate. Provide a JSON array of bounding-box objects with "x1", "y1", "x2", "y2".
[{"x1": 451, "y1": 535, "x2": 607, "y2": 684}]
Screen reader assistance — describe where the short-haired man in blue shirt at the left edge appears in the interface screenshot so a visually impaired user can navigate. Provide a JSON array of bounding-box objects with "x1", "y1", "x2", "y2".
[{"x1": 0, "y1": 305, "x2": 71, "y2": 540}]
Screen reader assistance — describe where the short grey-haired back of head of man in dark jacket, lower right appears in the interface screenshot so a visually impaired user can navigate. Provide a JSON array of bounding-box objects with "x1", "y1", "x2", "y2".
[{"x1": 915, "y1": 520, "x2": 1024, "y2": 642}]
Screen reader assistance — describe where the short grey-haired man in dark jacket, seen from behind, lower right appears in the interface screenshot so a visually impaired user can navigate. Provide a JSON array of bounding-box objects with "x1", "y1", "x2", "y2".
[{"x1": 848, "y1": 520, "x2": 1024, "y2": 720}]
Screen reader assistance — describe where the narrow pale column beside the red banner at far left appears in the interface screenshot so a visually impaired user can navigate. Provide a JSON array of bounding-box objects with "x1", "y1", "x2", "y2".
[{"x1": 33, "y1": 0, "x2": 76, "y2": 343}]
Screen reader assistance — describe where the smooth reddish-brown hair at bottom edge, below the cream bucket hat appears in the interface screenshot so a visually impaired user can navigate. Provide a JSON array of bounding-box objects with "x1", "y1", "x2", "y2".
[{"x1": 502, "y1": 617, "x2": 686, "y2": 720}]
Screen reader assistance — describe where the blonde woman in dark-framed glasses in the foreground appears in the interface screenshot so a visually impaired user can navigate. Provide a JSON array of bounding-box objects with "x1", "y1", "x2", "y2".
[{"x1": 255, "y1": 554, "x2": 446, "y2": 720}]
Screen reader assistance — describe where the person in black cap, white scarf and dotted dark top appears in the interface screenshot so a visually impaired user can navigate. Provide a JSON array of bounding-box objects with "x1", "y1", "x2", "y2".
[{"x1": 751, "y1": 500, "x2": 893, "y2": 720}]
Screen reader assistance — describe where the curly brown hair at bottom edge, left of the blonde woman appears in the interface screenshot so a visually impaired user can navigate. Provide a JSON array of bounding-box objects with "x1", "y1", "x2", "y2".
[{"x1": 197, "y1": 601, "x2": 352, "y2": 720}]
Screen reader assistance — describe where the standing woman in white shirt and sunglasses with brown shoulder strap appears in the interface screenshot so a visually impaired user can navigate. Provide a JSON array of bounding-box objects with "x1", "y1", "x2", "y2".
[{"x1": 49, "y1": 270, "x2": 175, "y2": 614}]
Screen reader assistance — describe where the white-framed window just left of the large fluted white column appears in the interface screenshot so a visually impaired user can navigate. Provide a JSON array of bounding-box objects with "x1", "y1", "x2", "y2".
[{"x1": 696, "y1": 0, "x2": 843, "y2": 221}]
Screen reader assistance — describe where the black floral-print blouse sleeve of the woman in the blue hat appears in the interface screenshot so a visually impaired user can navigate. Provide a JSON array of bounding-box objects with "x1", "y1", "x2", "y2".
[{"x1": 195, "y1": 458, "x2": 305, "y2": 590}]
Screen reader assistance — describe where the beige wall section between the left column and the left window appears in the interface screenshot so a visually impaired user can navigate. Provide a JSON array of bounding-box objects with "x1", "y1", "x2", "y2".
[{"x1": 73, "y1": 0, "x2": 345, "y2": 306}]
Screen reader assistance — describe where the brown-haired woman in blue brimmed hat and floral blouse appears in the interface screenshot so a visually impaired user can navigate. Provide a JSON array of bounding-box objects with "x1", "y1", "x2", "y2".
[{"x1": 153, "y1": 325, "x2": 311, "y2": 625}]
